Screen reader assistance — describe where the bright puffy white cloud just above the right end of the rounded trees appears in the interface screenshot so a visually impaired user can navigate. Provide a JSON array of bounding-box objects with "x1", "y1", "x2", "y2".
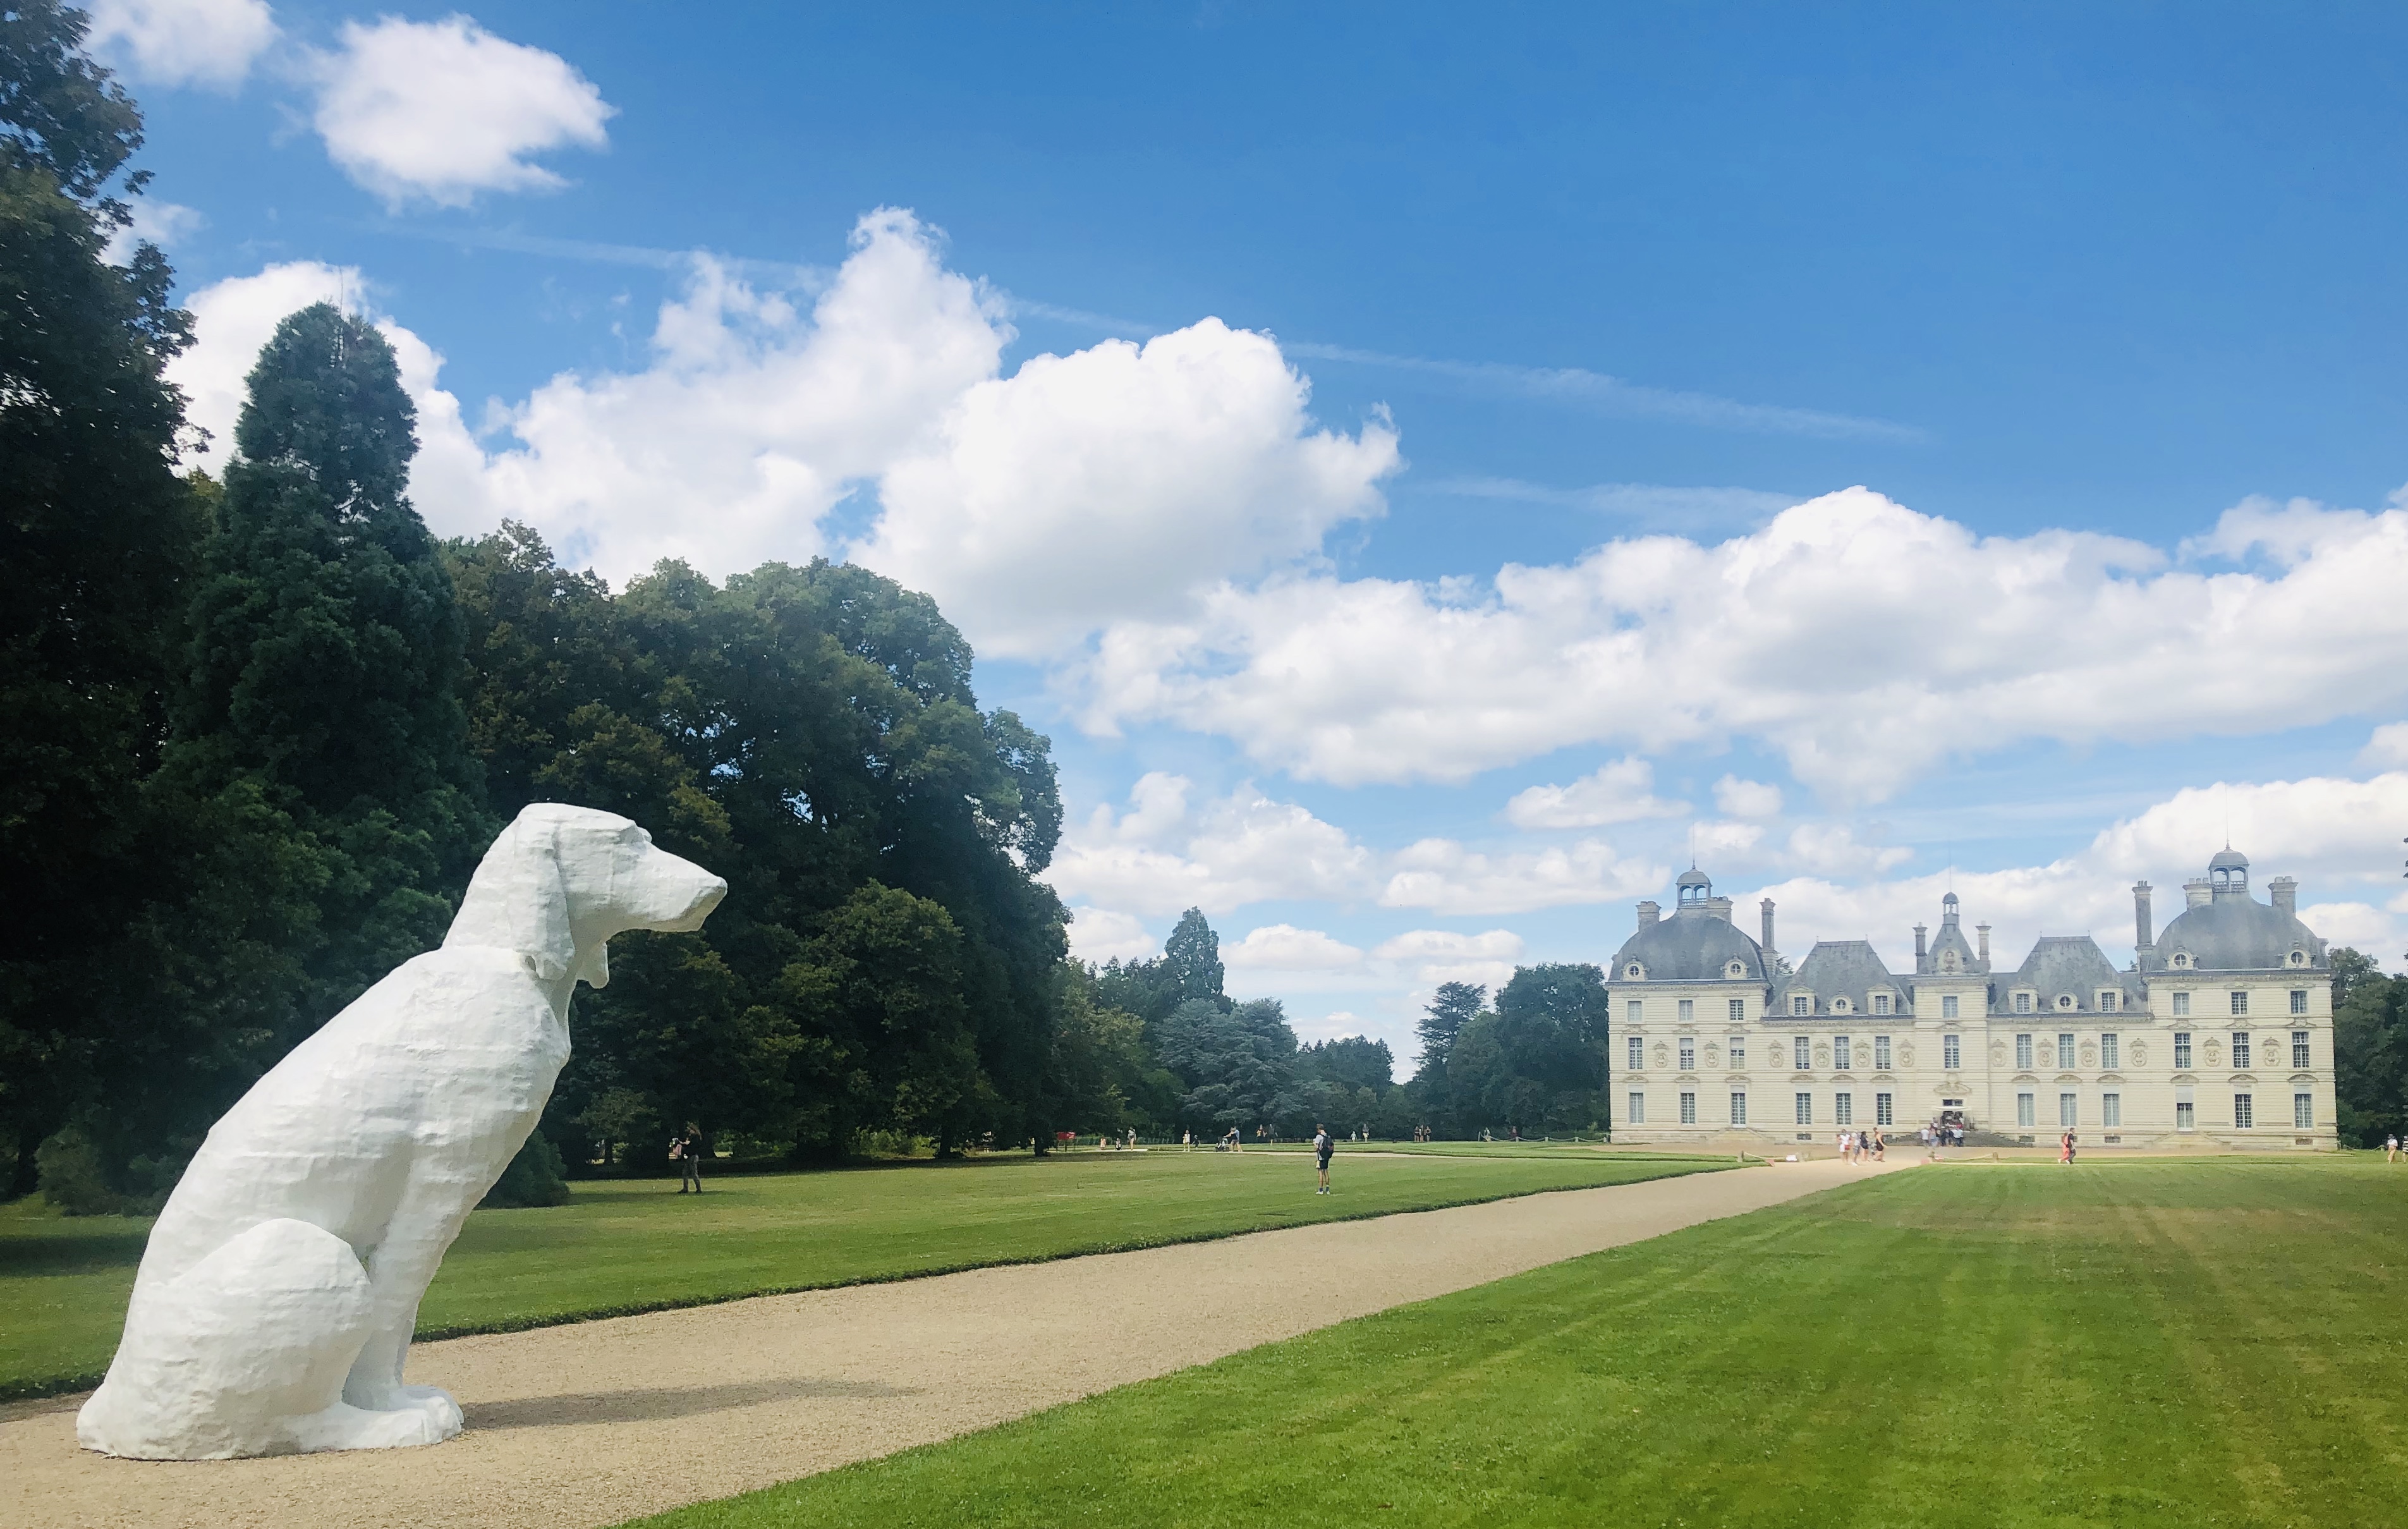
[{"x1": 855, "y1": 318, "x2": 1397, "y2": 655}]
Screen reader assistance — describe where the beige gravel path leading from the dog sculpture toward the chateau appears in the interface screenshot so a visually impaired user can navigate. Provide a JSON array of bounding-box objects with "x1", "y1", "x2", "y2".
[{"x1": 0, "y1": 1160, "x2": 1905, "y2": 1529}]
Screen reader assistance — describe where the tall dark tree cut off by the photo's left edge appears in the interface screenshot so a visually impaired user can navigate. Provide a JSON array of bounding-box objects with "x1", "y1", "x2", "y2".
[{"x1": 0, "y1": 0, "x2": 207, "y2": 1194}]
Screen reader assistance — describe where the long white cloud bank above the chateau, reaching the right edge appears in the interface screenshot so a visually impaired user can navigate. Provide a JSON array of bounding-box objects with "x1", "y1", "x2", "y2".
[{"x1": 1084, "y1": 489, "x2": 2408, "y2": 802}]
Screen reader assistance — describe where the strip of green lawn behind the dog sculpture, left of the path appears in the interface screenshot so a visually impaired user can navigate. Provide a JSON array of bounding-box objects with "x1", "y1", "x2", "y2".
[{"x1": 0, "y1": 1151, "x2": 1719, "y2": 1396}]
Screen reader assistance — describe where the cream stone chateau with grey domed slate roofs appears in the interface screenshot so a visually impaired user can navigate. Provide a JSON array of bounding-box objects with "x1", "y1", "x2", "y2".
[{"x1": 1606, "y1": 850, "x2": 2336, "y2": 1151}]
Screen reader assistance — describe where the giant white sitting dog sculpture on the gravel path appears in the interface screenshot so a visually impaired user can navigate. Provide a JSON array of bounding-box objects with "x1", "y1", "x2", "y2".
[{"x1": 75, "y1": 802, "x2": 727, "y2": 1459}]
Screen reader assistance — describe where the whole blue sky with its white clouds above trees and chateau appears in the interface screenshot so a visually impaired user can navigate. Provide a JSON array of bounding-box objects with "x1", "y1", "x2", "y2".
[{"x1": 99, "y1": 0, "x2": 2408, "y2": 1064}]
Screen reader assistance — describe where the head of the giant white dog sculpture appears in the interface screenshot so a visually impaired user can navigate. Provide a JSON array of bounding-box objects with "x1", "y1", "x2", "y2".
[{"x1": 443, "y1": 802, "x2": 727, "y2": 987}]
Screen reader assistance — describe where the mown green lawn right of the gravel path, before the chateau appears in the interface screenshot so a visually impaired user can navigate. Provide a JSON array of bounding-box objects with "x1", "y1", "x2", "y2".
[{"x1": 645, "y1": 1158, "x2": 2408, "y2": 1529}]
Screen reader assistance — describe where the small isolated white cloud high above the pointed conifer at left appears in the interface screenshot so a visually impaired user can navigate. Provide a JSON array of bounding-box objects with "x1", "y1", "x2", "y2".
[{"x1": 310, "y1": 15, "x2": 619, "y2": 207}]
